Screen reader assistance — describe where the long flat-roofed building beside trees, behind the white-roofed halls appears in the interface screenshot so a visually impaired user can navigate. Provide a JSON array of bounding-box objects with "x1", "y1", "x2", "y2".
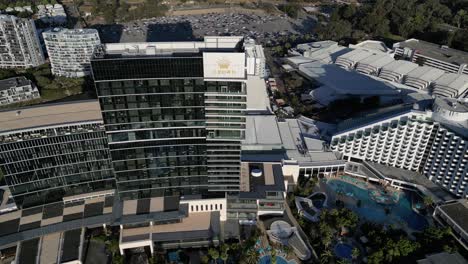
[{"x1": 393, "y1": 39, "x2": 468, "y2": 74}]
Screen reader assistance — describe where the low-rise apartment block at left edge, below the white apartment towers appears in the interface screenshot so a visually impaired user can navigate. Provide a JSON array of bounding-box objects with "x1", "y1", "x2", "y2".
[{"x1": 0, "y1": 76, "x2": 41, "y2": 105}]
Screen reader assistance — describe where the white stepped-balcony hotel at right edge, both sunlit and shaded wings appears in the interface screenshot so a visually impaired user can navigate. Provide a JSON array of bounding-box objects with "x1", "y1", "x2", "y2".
[{"x1": 331, "y1": 98, "x2": 468, "y2": 197}]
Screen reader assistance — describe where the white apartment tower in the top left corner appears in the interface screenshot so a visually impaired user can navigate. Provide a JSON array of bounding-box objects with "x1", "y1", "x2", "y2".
[{"x1": 0, "y1": 15, "x2": 44, "y2": 68}]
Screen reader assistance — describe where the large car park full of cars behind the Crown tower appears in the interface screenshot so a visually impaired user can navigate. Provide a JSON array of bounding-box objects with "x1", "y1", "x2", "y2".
[{"x1": 96, "y1": 13, "x2": 315, "y2": 45}]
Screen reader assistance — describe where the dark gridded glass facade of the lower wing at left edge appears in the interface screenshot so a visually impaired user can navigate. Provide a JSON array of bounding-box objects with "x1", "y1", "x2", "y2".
[{"x1": 0, "y1": 123, "x2": 115, "y2": 208}]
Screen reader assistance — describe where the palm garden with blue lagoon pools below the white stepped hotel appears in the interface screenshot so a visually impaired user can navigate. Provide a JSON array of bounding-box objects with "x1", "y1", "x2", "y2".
[{"x1": 288, "y1": 174, "x2": 466, "y2": 263}]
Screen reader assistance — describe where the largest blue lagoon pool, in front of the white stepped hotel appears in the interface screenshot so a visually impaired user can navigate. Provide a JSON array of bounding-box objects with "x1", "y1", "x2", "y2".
[{"x1": 327, "y1": 180, "x2": 428, "y2": 230}]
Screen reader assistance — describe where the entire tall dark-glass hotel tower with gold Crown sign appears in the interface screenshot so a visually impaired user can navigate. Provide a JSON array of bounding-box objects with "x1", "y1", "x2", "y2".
[{"x1": 91, "y1": 37, "x2": 265, "y2": 199}]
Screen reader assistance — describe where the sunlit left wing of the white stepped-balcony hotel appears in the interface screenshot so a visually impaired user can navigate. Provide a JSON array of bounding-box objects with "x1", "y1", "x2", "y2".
[{"x1": 331, "y1": 106, "x2": 434, "y2": 171}]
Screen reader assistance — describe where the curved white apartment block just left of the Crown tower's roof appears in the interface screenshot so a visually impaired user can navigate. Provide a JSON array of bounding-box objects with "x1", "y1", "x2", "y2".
[{"x1": 42, "y1": 28, "x2": 101, "y2": 77}]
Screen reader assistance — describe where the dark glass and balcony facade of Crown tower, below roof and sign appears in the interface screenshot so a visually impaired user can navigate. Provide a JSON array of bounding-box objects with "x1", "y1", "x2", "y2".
[{"x1": 92, "y1": 57, "x2": 246, "y2": 199}]
